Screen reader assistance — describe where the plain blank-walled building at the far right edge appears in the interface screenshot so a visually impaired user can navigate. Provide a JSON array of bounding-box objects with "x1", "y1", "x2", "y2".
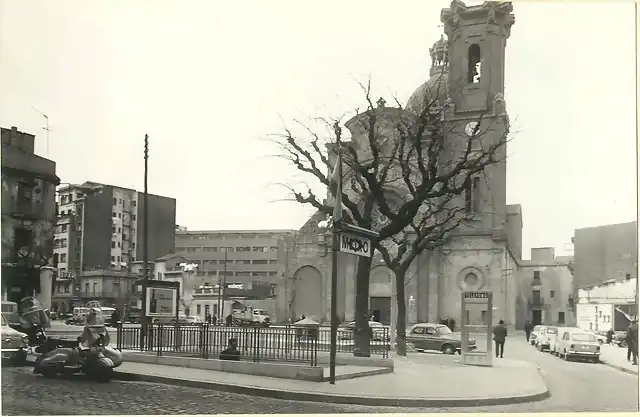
[{"x1": 573, "y1": 222, "x2": 638, "y2": 288}]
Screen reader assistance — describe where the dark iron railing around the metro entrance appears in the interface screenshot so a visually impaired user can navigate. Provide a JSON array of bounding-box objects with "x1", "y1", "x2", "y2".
[{"x1": 117, "y1": 323, "x2": 389, "y2": 366}]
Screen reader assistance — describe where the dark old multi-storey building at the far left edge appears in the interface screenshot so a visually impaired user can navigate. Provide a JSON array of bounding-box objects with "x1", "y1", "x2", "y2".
[{"x1": 0, "y1": 127, "x2": 60, "y2": 307}]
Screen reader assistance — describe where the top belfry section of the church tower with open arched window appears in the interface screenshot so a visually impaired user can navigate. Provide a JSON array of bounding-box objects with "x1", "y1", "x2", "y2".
[{"x1": 440, "y1": 0, "x2": 515, "y2": 114}]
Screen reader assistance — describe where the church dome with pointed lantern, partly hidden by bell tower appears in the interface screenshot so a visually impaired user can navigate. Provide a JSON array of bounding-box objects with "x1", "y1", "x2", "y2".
[{"x1": 405, "y1": 35, "x2": 449, "y2": 113}]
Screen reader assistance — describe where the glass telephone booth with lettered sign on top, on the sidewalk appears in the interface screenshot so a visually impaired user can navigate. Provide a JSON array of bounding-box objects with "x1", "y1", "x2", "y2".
[{"x1": 460, "y1": 291, "x2": 493, "y2": 366}]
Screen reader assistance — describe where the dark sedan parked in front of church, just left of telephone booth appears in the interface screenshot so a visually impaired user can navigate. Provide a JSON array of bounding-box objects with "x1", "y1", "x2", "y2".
[{"x1": 407, "y1": 323, "x2": 476, "y2": 355}]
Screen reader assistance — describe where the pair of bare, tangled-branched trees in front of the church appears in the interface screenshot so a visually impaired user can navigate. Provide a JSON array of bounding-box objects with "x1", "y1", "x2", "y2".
[{"x1": 279, "y1": 70, "x2": 509, "y2": 355}]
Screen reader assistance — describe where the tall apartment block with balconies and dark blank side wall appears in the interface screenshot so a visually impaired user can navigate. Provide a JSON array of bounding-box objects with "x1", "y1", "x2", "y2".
[{"x1": 54, "y1": 181, "x2": 176, "y2": 308}]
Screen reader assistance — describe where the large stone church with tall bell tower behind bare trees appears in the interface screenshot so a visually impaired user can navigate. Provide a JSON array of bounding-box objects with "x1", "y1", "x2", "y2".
[{"x1": 276, "y1": 1, "x2": 522, "y2": 327}]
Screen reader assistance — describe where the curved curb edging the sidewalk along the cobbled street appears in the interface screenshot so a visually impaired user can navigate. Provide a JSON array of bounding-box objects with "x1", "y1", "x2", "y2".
[{"x1": 27, "y1": 359, "x2": 551, "y2": 408}]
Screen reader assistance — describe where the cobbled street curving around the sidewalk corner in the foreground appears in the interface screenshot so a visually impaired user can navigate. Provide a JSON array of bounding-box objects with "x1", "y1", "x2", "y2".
[{"x1": 2, "y1": 336, "x2": 638, "y2": 415}]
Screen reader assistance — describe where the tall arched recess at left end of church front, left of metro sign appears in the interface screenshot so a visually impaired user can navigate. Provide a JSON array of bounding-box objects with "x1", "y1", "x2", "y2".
[{"x1": 291, "y1": 266, "x2": 324, "y2": 320}]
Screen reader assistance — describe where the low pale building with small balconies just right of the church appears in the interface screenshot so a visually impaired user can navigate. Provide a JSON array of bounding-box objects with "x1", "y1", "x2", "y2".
[{"x1": 516, "y1": 248, "x2": 576, "y2": 329}]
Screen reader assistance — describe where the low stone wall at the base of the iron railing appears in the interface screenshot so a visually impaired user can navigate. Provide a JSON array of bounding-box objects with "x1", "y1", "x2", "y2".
[{"x1": 123, "y1": 352, "x2": 324, "y2": 382}]
